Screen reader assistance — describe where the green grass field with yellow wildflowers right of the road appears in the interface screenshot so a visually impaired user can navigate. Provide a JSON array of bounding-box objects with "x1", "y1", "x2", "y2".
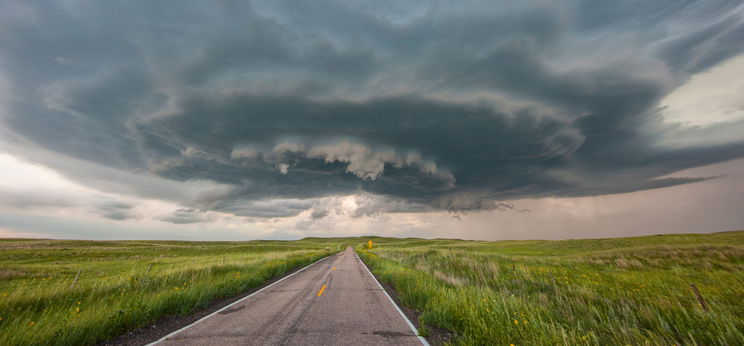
[{"x1": 357, "y1": 232, "x2": 744, "y2": 345}]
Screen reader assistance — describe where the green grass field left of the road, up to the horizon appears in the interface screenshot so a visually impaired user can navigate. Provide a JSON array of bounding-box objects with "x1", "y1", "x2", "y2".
[{"x1": 0, "y1": 239, "x2": 343, "y2": 345}]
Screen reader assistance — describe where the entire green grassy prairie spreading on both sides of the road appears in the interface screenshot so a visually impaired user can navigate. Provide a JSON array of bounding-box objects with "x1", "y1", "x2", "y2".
[{"x1": 0, "y1": 232, "x2": 744, "y2": 345}]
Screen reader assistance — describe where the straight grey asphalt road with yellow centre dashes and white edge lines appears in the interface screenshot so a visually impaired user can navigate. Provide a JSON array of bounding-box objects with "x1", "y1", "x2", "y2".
[{"x1": 153, "y1": 248, "x2": 422, "y2": 346}]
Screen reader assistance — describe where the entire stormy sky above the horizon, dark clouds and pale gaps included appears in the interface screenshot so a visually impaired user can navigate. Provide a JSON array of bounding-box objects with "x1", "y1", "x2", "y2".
[{"x1": 0, "y1": 0, "x2": 744, "y2": 240}]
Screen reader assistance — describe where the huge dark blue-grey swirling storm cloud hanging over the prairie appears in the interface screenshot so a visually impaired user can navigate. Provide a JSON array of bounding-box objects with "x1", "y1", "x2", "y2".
[{"x1": 0, "y1": 1, "x2": 744, "y2": 218}]
